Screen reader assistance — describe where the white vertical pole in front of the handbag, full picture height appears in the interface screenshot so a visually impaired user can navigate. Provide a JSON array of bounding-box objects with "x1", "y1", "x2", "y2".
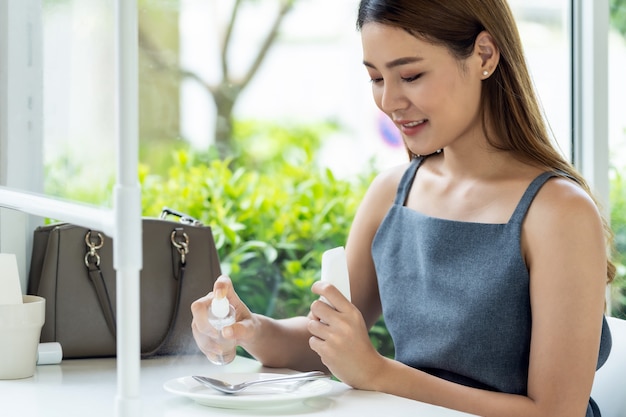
[{"x1": 113, "y1": 0, "x2": 142, "y2": 417}]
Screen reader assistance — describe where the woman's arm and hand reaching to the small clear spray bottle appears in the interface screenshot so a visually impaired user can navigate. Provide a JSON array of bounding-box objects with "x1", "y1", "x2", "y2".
[{"x1": 192, "y1": 162, "x2": 406, "y2": 370}]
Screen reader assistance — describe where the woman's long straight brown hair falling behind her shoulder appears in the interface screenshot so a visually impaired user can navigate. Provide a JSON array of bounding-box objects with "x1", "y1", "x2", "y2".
[{"x1": 356, "y1": 0, "x2": 615, "y2": 282}]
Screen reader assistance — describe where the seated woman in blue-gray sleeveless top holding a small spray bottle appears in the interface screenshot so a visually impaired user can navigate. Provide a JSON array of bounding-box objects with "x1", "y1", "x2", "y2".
[{"x1": 192, "y1": 0, "x2": 614, "y2": 417}]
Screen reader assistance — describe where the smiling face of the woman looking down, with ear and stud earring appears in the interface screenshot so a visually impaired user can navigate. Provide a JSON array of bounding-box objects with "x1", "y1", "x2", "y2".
[{"x1": 361, "y1": 22, "x2": 490, "y2": 155}]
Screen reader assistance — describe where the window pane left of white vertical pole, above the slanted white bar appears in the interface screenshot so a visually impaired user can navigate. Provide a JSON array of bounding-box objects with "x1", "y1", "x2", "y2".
[{"x1": 42, "y1": 0, "x2": 116, "y2": 206}]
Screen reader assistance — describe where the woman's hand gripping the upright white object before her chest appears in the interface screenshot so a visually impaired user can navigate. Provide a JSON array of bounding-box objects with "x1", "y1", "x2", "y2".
[{"x1": 308, "y1": 281, "x2": 383, "y2": 389}]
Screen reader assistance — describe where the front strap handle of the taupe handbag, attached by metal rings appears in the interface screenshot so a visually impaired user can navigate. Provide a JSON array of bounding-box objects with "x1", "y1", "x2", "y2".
[{"x1": 85, "y1": 228, "x2": 189, "y2": 358}]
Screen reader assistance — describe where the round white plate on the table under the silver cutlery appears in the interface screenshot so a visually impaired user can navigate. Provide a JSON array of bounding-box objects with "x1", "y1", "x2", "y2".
[{"x1": 163, "y1": 372, "x2": 332, "y2": 409}]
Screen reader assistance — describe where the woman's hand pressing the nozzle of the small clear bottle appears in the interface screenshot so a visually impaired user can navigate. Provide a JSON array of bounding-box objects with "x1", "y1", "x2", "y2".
[{"x1": 191, "y1": 275, "x2": 255, "y2": 357}]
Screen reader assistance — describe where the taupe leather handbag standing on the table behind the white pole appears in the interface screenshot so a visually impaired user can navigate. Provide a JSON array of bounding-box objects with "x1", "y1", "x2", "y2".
[{"x1": 28, "y1": 208, "x2": 221, "y2": 358}]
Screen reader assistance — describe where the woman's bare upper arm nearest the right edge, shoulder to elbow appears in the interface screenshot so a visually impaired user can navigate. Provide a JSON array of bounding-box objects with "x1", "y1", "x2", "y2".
[{"x1": 523, "y1": 179, "x2": 607, "y2": 415}]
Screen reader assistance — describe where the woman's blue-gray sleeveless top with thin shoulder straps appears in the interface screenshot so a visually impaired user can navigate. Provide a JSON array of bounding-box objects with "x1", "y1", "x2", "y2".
[{"x1": 372, "y1": 158, "x2": 611, "y2": 417}]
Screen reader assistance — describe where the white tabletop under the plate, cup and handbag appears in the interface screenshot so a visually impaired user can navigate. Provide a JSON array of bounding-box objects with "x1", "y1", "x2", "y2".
[{"x1": 0, "y1": 355, "x2": 468, "y2": 417}]
